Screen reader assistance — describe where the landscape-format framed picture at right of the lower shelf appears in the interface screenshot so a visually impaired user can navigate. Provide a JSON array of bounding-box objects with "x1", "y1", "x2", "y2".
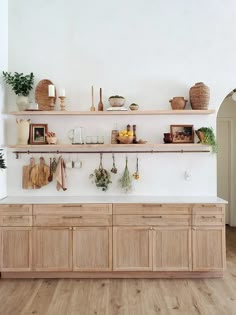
[{"x1": 170, "y1": 125, "x2": 194, "y2": 143}]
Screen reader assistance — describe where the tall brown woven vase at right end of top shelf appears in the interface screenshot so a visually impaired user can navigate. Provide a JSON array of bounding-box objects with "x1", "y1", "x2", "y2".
[{"x1": 189, "y1": 82, "x2": 210, "y2": 109}]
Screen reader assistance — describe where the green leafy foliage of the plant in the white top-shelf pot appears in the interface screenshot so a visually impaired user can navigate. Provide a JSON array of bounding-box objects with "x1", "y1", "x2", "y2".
[{"x1": 2, "y1": 71, "x2": 34, "y2": 96}]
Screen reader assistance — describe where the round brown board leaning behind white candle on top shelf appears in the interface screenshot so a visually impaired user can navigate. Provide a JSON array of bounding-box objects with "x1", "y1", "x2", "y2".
[{"x1": 35, "y1": 79, "x2": 56, "y2": 110}]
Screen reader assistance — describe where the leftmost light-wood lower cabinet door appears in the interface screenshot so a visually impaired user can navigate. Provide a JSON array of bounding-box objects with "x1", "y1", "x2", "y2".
[{"x1": 1, "y1": 227, "x2": 32, "y2": 271}]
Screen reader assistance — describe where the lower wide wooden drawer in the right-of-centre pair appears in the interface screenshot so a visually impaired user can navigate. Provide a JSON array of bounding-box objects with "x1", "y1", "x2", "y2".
[{"x1": 113, "y1": 214, "x2": 191, "y2": 226}]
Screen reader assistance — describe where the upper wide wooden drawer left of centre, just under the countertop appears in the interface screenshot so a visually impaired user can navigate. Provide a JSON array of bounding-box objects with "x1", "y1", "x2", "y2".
[{"x1": 33, "y1": 203, "x2": 112, "y2": 215}]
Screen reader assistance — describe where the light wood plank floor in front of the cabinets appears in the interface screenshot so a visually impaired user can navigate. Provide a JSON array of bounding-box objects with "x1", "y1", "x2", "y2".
[{"x1": 0, "y1": 228, "x2": 236, "y2": 315}]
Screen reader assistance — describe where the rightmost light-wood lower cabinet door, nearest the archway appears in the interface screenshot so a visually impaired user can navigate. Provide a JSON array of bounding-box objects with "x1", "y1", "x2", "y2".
[{"x1": 192, "y1": 227, "x2": 225, "y2": 271}]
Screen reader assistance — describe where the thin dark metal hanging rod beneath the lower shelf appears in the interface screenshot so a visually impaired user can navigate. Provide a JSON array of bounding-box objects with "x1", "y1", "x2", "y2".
[{"x1": 13, "y1": 150, "x2": 211, "y2": 159}]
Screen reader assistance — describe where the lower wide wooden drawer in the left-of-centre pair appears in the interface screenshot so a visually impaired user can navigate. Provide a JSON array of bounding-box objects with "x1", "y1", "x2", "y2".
[{"x1": 33, "y1": 214, "x2": 112, "y2": 227}]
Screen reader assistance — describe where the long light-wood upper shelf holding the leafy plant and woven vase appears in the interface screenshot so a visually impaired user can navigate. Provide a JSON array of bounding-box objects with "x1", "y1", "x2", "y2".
[{"x1": 10, "y1": 109, "x2": 215, "y2": 116}]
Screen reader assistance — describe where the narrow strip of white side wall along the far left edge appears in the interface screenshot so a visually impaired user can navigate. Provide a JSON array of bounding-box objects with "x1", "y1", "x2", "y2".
[{"x1": 0, "y1": 0, "x2": 8, "y2": 199}]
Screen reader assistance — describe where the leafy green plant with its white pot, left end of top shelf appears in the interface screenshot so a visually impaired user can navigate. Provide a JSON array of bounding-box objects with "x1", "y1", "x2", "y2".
[{"x1": 2, "y1": 71, "x2": 34, "y2": 110}]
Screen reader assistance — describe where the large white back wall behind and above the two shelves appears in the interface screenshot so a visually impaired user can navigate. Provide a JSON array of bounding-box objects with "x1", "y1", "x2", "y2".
[{"x1": 5, "y1": 0, "x2": 236, "y2": 195}]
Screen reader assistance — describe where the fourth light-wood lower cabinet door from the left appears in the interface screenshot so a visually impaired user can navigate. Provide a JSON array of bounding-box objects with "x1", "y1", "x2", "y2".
[{"x1": 113, "y1": 227, "x2": 152, "y2": 271}]
